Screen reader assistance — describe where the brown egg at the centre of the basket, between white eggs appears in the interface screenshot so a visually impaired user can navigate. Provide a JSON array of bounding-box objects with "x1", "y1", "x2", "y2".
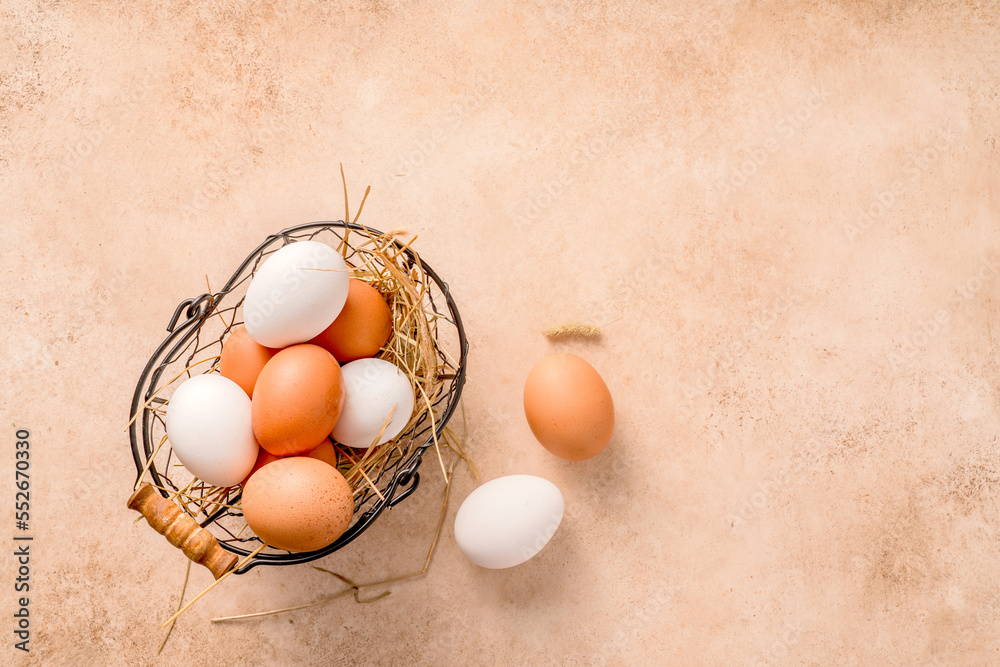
[{"x1": 250, "y1": 343, "x2": 344, "y2": 456}]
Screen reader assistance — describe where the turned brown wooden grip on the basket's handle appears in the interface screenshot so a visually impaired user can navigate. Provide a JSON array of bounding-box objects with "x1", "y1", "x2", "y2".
[{"x1": 128, "y1": 484, "x2": 238, "y2": 579}]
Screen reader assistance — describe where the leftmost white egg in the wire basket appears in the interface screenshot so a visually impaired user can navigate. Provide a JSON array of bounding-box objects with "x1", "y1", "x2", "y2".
[{"x1": 166, "y1": 373, "x2": 258, "y2": 486}]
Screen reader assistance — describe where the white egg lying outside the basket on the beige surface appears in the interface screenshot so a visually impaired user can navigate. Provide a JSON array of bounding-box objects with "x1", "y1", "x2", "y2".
[{"x1": 455, "y1": 475, "x2": 565, "y2": 570}]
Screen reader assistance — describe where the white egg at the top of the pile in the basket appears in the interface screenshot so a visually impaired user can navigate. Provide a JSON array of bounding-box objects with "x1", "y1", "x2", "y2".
[{"x1": 243, "y1": 241, "x2": 350, "y2": 347}]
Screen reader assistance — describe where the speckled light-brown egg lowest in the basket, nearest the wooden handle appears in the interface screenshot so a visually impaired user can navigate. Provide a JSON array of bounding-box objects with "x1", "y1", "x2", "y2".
[{"x1": 242, "y1": 456, "x2": 354, "y2": 552}]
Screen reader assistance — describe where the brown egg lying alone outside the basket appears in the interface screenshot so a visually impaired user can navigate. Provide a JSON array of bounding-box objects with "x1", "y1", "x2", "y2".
[{"x1": 524, "y1": 354, "x2": 615, "y2": 461}]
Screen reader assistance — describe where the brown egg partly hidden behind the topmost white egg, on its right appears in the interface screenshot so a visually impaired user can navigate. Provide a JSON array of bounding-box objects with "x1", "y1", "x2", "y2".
[{"x1": 309, "y1": 278, "x2": 392, "y2": 364}]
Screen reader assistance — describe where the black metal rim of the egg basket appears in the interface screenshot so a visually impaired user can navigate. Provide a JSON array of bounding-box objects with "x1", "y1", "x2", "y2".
[{"x1": 129, "y1": 220, "x2": 469, "y2": 574}]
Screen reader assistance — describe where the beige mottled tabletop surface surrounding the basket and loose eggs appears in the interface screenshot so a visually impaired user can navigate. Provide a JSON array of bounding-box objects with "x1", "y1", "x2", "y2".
[{"x1": 0, "y1": 0, "x2": 1000, "y2": 665}]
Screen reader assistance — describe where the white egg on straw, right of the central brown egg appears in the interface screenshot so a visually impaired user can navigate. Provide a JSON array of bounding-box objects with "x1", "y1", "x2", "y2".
[{"x1": 330, "y1": 359, "x2": 414, "y2": 449}]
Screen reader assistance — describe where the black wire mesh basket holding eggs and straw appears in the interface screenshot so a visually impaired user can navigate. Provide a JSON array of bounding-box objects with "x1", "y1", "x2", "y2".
[{"x1": 129, "y1": 221, "x2": 469, "y2": 574}]
